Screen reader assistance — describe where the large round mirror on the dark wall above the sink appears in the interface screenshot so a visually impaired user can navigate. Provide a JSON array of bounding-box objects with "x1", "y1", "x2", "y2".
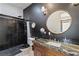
[{"x1": 46, "y1": 11, "x2": 72, "y2": 34}]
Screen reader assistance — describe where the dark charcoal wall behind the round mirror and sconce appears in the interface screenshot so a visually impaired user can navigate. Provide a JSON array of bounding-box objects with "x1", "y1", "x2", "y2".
[{"x1": 24, "y1": 3, "x2": 79, "y2": 44}]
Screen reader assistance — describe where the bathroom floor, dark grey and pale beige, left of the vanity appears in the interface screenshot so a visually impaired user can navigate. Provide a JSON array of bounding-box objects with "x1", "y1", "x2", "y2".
[{"x1": 0, "y1": 45, "x2": 34, "y2": 56}]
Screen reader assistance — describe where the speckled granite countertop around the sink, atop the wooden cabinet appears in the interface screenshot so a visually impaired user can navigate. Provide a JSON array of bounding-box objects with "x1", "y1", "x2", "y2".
[{"x1": 34, "y1": 38, "x2": 79, "y2": 56}]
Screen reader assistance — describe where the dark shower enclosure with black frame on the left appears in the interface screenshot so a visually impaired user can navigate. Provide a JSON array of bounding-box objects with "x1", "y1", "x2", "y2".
[{"x1": 0, "y1": 15, "x2": 24, "y2": 50}]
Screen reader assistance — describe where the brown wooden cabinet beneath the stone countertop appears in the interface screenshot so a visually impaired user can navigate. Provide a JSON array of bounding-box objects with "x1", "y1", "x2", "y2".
[{"x1": 33, "y1": 42, "x2": 64, "y2": 56}]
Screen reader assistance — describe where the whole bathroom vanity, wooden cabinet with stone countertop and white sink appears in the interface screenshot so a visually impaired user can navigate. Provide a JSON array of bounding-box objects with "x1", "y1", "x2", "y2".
[{"x1": 33, "y1": 39, "x2": 79, "y2": 56}]
